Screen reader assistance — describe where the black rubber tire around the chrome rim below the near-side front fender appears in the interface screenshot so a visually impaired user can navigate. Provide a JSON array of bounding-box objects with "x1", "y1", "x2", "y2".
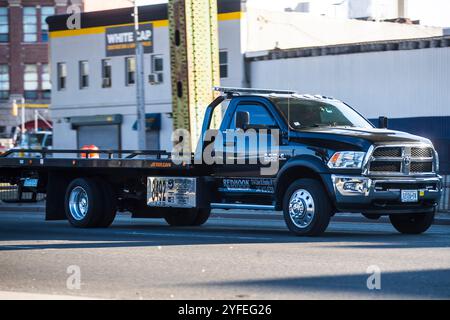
[{"x1": 283, "y1": 179, "x2": 333, "y2": 236}]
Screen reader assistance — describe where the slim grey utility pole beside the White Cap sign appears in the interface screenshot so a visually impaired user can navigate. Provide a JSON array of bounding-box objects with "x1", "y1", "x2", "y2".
[{"x1": 133, "y1": 0, "x2": 147, "y2": 150}]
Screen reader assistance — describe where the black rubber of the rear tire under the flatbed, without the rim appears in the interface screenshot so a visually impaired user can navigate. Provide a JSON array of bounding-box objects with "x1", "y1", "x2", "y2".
[{"x1": 64, "y1": 178, "x2": 103, "y2": 228}]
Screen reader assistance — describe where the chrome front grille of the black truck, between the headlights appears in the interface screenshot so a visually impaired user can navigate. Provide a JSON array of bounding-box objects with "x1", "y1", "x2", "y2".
[{"x1": 366, "y1": 146, "x2": 435, "y2": 176}]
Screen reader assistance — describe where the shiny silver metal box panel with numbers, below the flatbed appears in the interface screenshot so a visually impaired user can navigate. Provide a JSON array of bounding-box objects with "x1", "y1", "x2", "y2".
[{"x1": 147, "y1": 177, "x2": 197, "y2": 208}]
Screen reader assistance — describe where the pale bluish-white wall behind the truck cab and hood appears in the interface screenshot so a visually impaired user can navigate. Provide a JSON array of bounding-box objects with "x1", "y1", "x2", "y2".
[{"x1": 251, "y1": 48, "x2": 450, "y2": 118}]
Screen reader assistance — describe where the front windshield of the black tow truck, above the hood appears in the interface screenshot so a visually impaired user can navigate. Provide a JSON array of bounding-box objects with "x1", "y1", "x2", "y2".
[{"x1": 271, "y1": 98, "x2": 373, "y2": 129}]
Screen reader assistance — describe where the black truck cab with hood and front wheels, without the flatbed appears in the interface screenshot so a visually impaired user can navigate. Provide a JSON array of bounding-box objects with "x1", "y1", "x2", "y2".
[{"x1": 201, "y1": 88, "x2": 442, "y2": 235}]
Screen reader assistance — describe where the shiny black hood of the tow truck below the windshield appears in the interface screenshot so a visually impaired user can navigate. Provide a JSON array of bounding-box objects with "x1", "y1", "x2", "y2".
[{"x1": 291, "y1": 127, "x2": 431, "y2": 151}]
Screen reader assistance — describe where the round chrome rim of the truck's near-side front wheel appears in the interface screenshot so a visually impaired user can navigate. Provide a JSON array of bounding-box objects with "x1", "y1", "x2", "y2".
[{"x1": 289, "y1": 189, "x2": 315, "y2": 229}]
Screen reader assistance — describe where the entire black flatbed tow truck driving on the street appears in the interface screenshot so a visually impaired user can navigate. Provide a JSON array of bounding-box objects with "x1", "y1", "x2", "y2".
[{"x1": 0, "y1": 88, "x2": 442, "y2": 236}]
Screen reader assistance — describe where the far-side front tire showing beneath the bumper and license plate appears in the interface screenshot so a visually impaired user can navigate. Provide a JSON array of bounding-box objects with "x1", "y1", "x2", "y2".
[{"x1": 389, "y1": 212, "x2": 434, "y2": 234}]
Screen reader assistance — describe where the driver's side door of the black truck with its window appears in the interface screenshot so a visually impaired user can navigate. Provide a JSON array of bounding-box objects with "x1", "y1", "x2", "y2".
[{"x1": 214, "y1": 98, "x2": 280, "y2": 193}]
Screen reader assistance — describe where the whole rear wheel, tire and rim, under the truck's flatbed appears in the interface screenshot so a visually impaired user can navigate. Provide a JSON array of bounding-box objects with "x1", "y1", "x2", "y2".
[{"x1": 65, "y1": 178, "x2": 104, "y2": 228}]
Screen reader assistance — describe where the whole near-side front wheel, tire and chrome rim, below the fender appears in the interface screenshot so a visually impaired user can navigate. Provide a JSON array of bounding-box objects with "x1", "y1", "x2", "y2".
[{"x1": 283, "y1": 179, "x2": 332, "y2": 236}]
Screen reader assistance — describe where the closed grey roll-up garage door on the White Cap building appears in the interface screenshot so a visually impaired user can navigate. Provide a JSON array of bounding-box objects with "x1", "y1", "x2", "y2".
[{"x1": 78, "y1": 125, "x2": 120, "y2": 150}]
